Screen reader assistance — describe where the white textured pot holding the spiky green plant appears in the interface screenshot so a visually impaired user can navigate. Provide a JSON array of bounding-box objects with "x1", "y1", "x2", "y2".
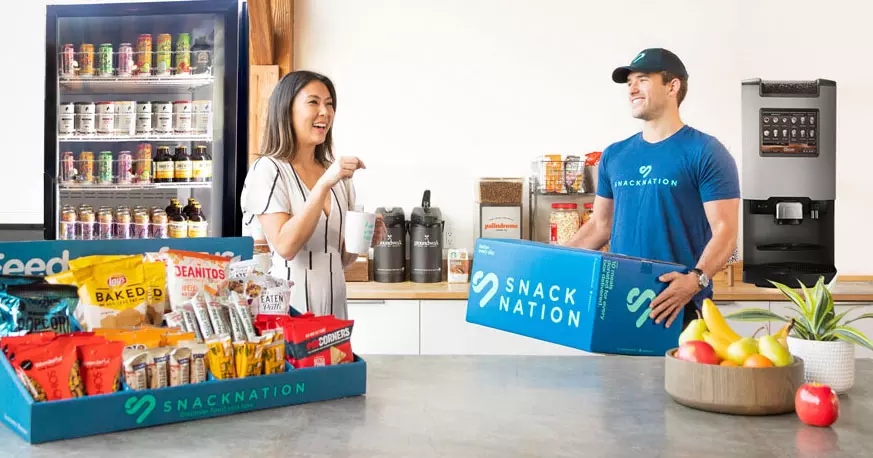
[{"x1": 788, "y1": 337, "x2": 855, "y2": 393}]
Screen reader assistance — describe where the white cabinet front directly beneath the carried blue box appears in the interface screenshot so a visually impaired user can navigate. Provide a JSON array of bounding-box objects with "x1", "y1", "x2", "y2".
[{"x1": 421, "y1": 300, "x2": 590, "y2": 355}]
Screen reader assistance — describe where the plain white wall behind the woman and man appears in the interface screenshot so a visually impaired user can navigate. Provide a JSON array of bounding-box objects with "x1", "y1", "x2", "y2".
[{"x1": 295, "y1": 0, "x2": 873, "y2": 274}]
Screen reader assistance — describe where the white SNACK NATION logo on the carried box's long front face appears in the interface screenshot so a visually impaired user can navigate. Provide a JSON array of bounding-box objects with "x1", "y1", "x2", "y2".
[{"x1": 471, "y1": 271, "x2": 582, "y2": 328}]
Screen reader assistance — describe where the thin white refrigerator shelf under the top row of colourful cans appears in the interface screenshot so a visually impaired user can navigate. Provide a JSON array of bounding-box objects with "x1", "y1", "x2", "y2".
[{"x1": 58, "y1": 75, "x2": 215, "y2": 94}]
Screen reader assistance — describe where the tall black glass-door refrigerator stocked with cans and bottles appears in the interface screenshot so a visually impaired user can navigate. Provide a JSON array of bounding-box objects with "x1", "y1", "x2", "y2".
[{"x1": 45, "y1": 0, "x2": 248, "y2": 240}]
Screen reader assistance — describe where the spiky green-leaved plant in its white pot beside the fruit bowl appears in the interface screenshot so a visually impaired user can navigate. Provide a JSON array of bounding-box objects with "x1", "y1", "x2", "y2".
[{"x1": 725, "y1": 277, "x2": 873, "y2": 393}]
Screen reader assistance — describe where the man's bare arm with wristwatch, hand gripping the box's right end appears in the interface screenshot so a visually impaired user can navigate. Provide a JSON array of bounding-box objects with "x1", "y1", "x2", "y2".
[{"x1": 649, "y1": 199, "x2": 740, "y2": 328}]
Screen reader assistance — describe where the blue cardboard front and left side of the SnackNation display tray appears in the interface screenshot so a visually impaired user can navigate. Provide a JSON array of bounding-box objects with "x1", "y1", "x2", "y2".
[{"x1": 0, "y1": 355, "x2": 367, "y2": 444}]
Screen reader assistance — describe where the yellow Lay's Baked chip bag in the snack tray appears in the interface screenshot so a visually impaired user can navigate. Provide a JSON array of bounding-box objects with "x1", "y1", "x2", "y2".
[{"x1": 74, "y1": 256, "x2": 149, "y2": 329}]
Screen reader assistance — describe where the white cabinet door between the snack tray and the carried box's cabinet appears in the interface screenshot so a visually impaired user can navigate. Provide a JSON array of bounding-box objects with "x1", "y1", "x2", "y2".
[{"x1": 349, "y1": 300, "x2": 419, "y2": 357}]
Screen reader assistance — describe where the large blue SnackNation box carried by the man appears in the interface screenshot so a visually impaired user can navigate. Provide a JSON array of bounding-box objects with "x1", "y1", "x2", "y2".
[{"x1": 467, "y1": 239, "x2": 689, "y2": 356}]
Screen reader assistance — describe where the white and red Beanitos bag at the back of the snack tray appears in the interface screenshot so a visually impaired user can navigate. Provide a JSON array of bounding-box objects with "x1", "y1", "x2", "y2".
[{"x1": 166, "y1": 250, "x2": 231, "y2": 311}]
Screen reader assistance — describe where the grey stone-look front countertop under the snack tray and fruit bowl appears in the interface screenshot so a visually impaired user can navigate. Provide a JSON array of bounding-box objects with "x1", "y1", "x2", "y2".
[{"x1": 0, "y1": 356, "x2": 873, "y2": 458}]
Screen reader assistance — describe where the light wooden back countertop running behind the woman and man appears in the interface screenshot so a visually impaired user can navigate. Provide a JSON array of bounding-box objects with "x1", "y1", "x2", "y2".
[{"x1": 347, "y1": 281, "x2": 873, "y2": 303}]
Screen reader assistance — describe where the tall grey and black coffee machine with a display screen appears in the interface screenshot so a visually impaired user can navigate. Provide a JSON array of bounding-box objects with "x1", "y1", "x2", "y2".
[{"x1": 742, "y1": 79, "x2": 837, "y2": 287}]
